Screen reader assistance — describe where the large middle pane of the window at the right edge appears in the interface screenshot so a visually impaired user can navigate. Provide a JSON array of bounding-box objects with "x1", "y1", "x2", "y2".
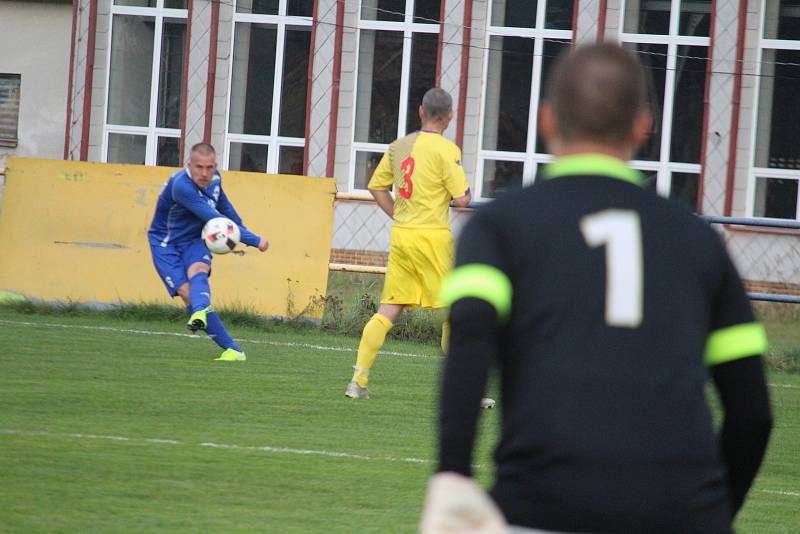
[{"x1": 756, "y1": 49, "x2": 800, "y2": 169}]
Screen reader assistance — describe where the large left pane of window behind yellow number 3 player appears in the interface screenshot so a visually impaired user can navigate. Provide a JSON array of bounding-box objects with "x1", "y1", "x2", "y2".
[{"x1": 355, "y1": 30, "x2": 403, "y2": 143}]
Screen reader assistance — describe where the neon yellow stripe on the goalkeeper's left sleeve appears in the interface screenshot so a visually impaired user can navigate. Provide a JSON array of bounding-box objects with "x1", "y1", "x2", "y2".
[{"x1": 442, "y1": 263, "x2": 512, "y2": 320}]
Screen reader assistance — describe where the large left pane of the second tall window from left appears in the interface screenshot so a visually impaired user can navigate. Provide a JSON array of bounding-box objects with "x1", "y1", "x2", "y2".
[{"x1": 228, "y1": 22, "x2": 276, "y2": 135}]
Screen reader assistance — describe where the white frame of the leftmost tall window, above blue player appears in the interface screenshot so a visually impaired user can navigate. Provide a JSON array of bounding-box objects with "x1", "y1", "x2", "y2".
[{"x1": 100, "y1": 0, "x2": 185, "y2": 165}]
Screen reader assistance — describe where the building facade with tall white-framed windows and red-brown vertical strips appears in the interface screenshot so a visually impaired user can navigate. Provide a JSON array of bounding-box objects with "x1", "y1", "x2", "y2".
[{"x1": 64, "y1": 0, "x2": 800, "y2": 285}]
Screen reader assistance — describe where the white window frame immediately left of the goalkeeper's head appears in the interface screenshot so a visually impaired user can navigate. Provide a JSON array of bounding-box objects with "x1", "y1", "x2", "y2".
[{"x1": 473, "y1": 0, "x2": 575, "y2": 200}]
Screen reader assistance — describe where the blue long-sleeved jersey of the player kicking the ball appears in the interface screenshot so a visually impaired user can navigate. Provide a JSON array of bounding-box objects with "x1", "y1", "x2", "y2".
[{"x1": 147, "y1": 169, "x2": 261, "y2": 247}]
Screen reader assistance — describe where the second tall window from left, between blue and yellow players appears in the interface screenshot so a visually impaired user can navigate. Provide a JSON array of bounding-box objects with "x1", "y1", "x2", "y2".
[{"x1": 224, "y1": 0, "x2": 313, "y2": 174}]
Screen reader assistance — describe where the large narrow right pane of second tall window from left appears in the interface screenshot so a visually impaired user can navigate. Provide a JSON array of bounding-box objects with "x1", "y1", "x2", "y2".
[{"x1": 279, "y1": 27, "x2": 311, "y2": 137}]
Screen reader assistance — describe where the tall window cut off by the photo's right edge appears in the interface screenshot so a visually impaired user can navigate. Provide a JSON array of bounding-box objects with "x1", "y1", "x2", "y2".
[{"x1": 748, "y1": 0, "x2": 800, "y2": 219}]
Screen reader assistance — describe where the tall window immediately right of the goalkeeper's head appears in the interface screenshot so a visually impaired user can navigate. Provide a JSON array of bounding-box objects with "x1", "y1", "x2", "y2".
[{"x1": 620, "y1": 0, "x2": 711, "y2": 209}]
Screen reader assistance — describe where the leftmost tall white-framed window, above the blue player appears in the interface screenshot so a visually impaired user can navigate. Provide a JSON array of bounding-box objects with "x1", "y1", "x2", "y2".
[{"x1": 103, "y1": 0, "x2": 187, "y2": 167}]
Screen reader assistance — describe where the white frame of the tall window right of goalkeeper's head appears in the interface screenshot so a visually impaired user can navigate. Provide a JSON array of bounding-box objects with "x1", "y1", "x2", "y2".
[{"x1": 619, "y1": 0, "x2": 711, "y2": 197}]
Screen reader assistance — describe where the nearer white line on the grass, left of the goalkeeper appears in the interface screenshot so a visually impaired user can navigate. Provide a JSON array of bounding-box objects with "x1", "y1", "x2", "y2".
[{"x1": 0, "y1": 428, "x2": 432, "y2": 467}]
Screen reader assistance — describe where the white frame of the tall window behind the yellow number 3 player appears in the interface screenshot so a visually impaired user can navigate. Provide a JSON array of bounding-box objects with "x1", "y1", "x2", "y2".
[{"x1": 347, "y1": 0, "x2": 445, "y2": 191}]
